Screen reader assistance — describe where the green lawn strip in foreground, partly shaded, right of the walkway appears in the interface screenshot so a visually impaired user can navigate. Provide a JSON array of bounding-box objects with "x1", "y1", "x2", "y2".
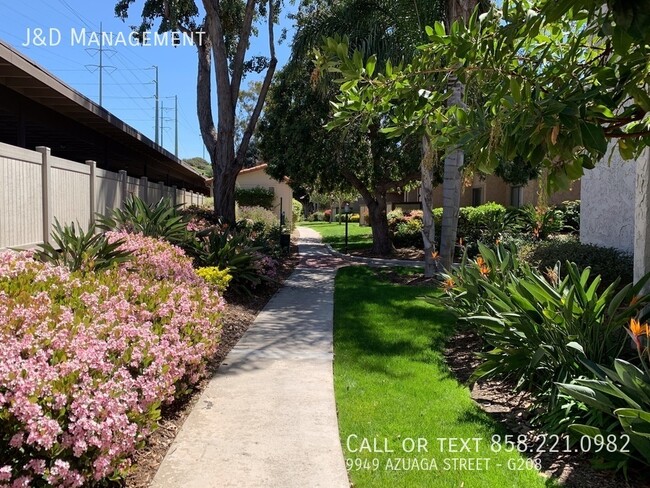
[{"x1": 334, "y1": 267, "x2": 555, "y2": 488}]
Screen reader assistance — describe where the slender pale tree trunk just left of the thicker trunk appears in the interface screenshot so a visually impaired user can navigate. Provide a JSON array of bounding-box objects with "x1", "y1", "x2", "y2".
[{"x1": 420, "y1": 136, "x2": 438, "y2": 278}]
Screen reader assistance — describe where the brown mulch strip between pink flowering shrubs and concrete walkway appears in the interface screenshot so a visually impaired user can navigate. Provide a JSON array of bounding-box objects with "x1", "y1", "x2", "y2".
[{"x1": 120, "y1": 246, "x2": 299, "y2": 488}]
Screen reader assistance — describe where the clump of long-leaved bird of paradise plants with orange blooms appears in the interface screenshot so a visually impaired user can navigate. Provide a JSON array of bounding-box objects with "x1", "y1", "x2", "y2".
[{"x1": 438, "y1": 244, "x2": 650, "y2": 468}]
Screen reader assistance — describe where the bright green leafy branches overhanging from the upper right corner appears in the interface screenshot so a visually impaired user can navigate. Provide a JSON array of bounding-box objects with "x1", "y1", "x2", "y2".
[{"x1": 320, "y1": 0, "x2": 650, "y2": 266}]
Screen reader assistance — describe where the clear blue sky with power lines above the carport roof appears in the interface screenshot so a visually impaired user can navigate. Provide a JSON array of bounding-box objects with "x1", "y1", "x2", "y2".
[{"x1": 0, "y1": 0, "x2": 297, "y2": 158}]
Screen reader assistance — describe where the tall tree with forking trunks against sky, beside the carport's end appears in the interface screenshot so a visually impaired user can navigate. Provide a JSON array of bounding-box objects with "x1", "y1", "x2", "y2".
[{"x1": 115, "y1": 0, "x2": 280, "y2": 221}]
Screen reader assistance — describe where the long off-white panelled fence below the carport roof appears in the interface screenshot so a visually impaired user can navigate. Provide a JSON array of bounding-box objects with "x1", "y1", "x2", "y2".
[{"x1": 0, "y1": 143, "x2": 205, "y2": 248}]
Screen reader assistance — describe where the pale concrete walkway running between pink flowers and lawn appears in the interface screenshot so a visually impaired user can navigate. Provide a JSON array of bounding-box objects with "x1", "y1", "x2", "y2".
[{"x1": 152, "y1": 228, "x2": 349, "y2": 488}]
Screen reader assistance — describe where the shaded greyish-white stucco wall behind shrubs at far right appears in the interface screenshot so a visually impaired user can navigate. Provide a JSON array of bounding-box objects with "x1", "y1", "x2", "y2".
[{"x1": 580, "y1": 149, "x2": 636, "y2": 254}]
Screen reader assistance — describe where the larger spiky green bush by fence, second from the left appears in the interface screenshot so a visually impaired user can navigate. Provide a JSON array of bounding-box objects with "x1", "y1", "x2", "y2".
[{"x1": 98, "y1": 196, "x2": 190, "y2": 245}]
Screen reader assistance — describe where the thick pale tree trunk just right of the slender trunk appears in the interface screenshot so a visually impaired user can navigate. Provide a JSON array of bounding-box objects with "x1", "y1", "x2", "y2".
[{"x1": 440, "y1": 80, "x2": 465, "y2": 270}]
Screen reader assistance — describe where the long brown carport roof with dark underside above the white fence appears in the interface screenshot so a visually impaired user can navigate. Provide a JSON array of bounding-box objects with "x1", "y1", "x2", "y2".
[{"x1": 0, "y1": 41, "x2": 206, "y2": 192}]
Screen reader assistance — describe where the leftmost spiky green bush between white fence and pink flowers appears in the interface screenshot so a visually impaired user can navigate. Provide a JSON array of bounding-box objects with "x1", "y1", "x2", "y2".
[{"x1": 36, "y1": 220, "x2": 130, "y2": 272}]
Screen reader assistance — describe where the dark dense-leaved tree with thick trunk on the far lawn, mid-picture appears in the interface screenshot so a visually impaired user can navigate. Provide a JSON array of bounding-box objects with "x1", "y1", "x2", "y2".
[{"x1": 259, "y1": 59, "x2": 419, "y2": 255}]
